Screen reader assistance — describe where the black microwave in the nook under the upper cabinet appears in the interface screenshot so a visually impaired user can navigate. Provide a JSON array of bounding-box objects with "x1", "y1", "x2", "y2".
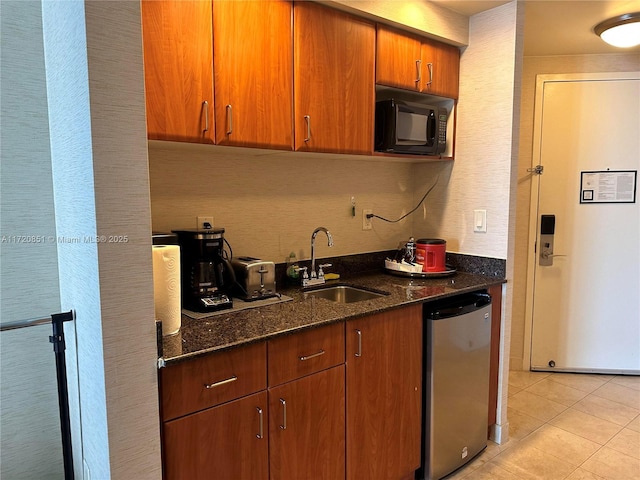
[{"x1": 374, "y1": 99, "x2": 447, "y2": 155}]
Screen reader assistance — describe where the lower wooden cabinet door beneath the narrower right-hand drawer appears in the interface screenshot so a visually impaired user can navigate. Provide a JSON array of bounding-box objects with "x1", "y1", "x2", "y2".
[{"x1": 269, "y1": 365, "x2": 344, "y2": 480}]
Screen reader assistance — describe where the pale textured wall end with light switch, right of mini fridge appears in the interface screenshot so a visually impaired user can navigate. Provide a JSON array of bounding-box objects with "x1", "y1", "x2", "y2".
[{"x1": 460, "y1": 2, "x2": 524, "y2": 443}]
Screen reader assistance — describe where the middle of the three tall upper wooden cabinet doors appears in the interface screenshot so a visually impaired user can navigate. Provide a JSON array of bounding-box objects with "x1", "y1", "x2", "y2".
[{"x1": 213, "y1": 0, "x2": 293, "y2": 150}]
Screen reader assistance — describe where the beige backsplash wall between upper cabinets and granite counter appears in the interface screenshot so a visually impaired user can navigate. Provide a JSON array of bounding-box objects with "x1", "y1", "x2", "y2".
[{"x1": 149, "y1": 142, "x2": 414, "y2": 263}]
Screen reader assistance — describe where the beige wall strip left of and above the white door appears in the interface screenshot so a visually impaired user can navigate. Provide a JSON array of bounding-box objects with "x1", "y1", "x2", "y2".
[{"x1": 511, "y1": 53, "x2": 640, "y2": 370}]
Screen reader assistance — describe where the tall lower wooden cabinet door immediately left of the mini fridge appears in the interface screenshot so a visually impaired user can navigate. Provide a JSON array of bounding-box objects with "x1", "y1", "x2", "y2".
[{"x1": 346, "y1": 305, "x2": 422, "y2": 480}]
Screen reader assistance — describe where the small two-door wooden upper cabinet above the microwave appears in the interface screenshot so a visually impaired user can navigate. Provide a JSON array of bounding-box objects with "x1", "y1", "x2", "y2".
[{"x1": 376, "y1": 25, "x2": 460, "y2": 99}]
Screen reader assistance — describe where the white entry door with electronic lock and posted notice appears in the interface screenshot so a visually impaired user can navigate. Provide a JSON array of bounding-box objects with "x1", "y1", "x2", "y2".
[{"x1": 528, "y1": 73, "x2": 640, "y2": 374}]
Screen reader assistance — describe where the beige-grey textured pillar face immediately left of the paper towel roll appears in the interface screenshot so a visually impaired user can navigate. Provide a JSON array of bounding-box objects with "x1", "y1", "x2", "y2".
[{"x1": 85, "y1": 1, "x2": 161, "y2": 480}]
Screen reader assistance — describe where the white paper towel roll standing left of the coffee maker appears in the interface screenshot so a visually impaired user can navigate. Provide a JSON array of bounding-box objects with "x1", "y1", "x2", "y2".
[{"x1": 153, "y1": 245, "x2": 182, "y2": 335}]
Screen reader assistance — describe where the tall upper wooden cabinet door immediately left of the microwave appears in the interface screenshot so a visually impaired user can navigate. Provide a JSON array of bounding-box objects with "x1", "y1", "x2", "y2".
[{"x1": 294, "y1": 2, "x2": 375, "y2": 154}]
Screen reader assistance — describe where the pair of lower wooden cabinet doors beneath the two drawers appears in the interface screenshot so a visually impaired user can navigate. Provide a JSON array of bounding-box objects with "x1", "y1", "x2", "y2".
[{"x1": 163, "y1": 364, "x2": 346, "y2": 480}]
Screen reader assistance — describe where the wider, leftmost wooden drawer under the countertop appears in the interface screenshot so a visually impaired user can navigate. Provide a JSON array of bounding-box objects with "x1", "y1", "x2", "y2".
[{"x1": 160, "y1": 342, "x2": 267, "y2": 421}]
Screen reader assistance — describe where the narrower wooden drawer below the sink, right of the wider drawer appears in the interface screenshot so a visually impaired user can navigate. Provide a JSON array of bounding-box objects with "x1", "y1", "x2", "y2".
[{"x1": 268, "y1": 322, "x2": 344, "y2": 386}]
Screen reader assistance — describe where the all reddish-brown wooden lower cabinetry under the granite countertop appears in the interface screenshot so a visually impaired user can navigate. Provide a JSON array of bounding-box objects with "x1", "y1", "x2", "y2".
[{"x1": 161, "y1": 298, "x2": 501, "y2": 480}]
